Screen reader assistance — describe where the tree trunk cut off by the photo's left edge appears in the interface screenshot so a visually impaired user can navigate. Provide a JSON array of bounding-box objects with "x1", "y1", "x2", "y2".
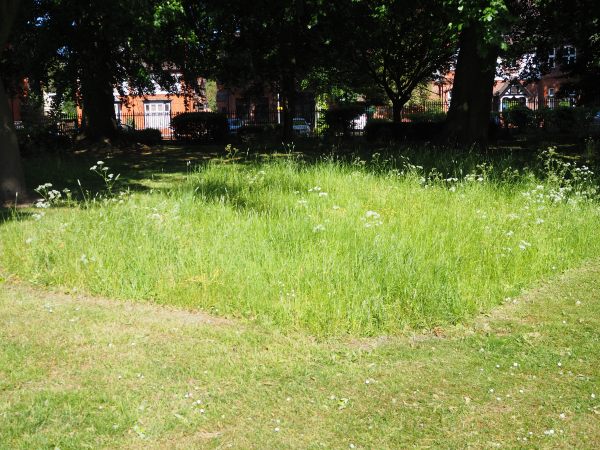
[{"x1": 0, "y1": 0, "x2": 27, "y2": 204}]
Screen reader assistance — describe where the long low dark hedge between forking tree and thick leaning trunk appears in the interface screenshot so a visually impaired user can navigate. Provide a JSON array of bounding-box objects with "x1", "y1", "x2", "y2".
[{"x1": 365, "y1": 119, "x2": 444, "y2": 141}]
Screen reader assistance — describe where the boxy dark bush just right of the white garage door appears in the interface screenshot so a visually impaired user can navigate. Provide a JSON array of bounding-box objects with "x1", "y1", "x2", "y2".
[{"x1": 171, "y1": 112, "x2": 228, "y2": 142}]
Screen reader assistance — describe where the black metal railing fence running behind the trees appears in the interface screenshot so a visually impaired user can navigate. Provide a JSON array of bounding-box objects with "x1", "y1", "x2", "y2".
[{"x1": 15, "y1": 97, "x2": 596, "y2": 140}]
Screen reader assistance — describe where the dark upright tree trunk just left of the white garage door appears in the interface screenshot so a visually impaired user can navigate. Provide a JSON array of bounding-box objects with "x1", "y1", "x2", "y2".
[{"x1": 81, "y1": 55, "x2": 117, "y2": 141}]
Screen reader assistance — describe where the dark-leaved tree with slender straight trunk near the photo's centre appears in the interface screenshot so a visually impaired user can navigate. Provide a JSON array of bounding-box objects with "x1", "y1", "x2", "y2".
[{"x1": 184, "y1": 0, "x2": 322, "y2": 140}]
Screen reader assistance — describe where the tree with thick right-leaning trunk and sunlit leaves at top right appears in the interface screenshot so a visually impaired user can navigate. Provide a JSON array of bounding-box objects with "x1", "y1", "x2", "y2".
[{"x1": 445, "y1": 0, "x2": 545, "y2": 146}]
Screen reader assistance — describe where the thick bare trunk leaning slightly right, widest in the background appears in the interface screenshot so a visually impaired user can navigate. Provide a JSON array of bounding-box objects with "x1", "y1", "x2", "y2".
[{"x1": 445, "y1": 25, "x2": 499, "y2": 146}]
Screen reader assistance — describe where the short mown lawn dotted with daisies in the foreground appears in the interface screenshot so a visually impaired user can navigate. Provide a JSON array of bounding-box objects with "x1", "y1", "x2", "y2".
[{"x1": 0, "y1": 264, "x2": 600, "y2": 450}]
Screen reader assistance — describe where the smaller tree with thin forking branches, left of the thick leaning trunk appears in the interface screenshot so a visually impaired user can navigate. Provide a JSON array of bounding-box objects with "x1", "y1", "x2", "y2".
[{"x1": 324, "y1": 0, "x2": 456, "y2": 121}]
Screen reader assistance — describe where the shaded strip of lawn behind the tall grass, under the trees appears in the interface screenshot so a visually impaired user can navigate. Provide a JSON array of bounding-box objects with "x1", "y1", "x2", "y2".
[{"x1": 16, "y1": 141, "x2": 596, "y2": 211}]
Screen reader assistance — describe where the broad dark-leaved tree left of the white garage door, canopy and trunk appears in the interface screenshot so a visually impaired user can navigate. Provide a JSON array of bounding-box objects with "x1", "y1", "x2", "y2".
[{"x1": 5, "y1": 0, "x2": 199, "y2": 141}]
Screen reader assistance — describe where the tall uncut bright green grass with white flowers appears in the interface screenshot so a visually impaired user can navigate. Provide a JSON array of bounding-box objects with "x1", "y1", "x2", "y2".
[{"x1": 0, "y1": 151, "x2": 600, "y2": 335}]
